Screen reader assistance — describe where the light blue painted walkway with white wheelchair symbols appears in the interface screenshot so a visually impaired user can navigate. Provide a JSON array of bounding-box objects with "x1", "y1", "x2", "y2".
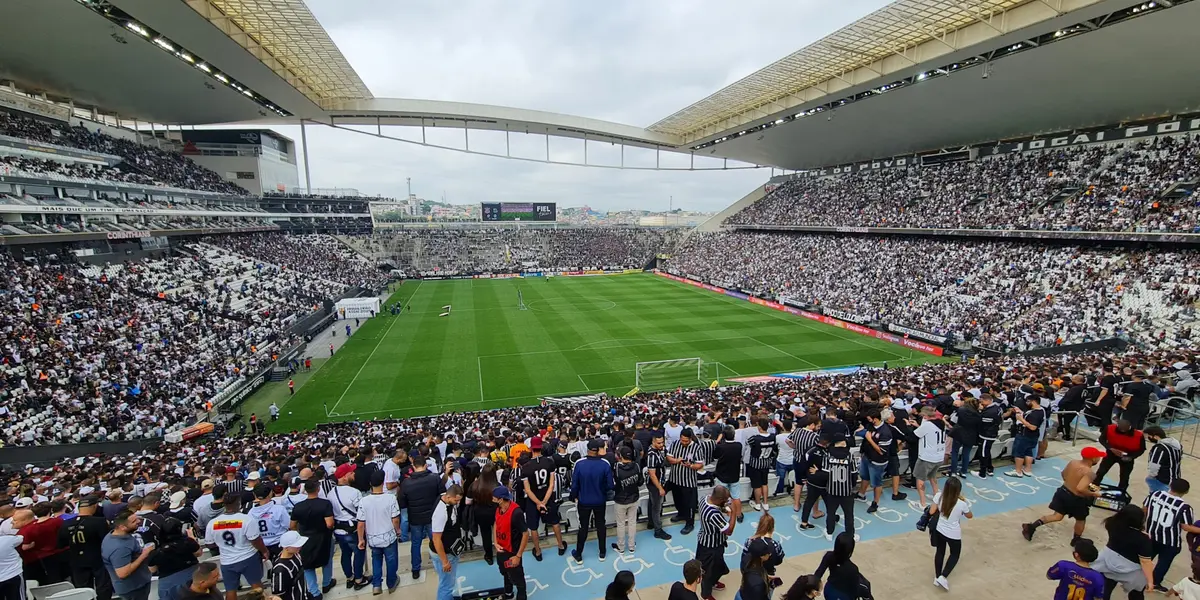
[{"x1": 458, "y1": 458, "x2": 1066, "y2": 600}]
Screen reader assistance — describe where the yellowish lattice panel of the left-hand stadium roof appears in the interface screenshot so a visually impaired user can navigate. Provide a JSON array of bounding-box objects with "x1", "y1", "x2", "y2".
[{"x1": 186, "y1": 0, "x2": 371, "y2": 108}]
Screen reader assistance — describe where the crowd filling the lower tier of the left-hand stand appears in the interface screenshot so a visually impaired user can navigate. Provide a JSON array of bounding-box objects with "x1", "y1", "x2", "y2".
[{"x1": 0, "y1": 233, "x2": 393, "y2": 445}]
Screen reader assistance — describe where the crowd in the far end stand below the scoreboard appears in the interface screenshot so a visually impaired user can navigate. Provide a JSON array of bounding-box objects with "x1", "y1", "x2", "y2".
[{"x1": 350, "y1": 227, "x2": 683, "y2": 275}]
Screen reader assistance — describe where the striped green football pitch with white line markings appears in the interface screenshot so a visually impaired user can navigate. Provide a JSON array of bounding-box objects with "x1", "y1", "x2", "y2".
[{"x1": 272, "y1": 274, "x2": 937, "y2": 431}]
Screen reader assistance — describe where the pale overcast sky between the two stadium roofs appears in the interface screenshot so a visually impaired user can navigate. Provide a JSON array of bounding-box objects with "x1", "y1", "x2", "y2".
[{"x1": 265, "y1": 0, "x2": 902, "y2": 211}]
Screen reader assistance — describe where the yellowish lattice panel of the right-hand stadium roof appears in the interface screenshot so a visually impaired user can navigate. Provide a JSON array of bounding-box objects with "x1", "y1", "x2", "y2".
[{"x1": 648, "y1": 0, "x2": 1099, "y2": 140}]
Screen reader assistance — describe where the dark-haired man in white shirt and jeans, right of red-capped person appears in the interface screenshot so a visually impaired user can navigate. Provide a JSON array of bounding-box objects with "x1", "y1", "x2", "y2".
[{"x1": 357, "y1": 470, "x2": 400, "y2": 595}]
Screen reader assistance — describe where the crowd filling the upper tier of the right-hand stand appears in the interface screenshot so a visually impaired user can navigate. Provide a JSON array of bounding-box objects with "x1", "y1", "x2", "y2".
[{"x1": 728, "y1": 134, "x2": 1200, "y2": 233}]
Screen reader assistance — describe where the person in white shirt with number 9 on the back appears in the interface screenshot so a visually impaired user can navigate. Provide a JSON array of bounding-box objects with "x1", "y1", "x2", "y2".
[{"x1": 204, "y1": 494, "x2": 270, "y2": 600}]
